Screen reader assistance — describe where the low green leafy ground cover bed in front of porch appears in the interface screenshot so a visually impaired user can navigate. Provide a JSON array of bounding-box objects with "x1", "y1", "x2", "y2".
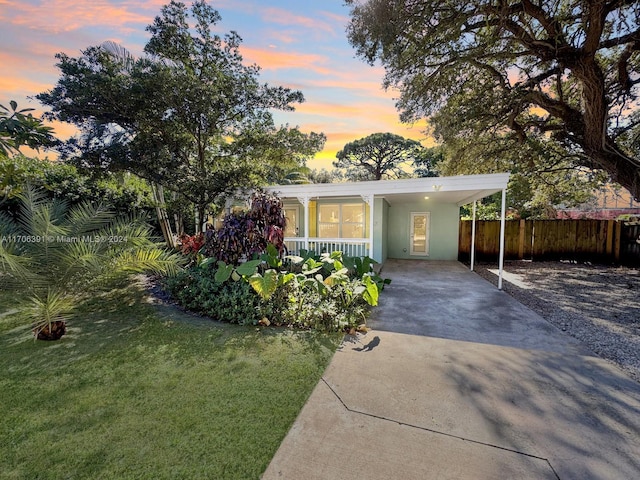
[{"x1": 165, "y1": 245, "x2": 389, "y2": 331}]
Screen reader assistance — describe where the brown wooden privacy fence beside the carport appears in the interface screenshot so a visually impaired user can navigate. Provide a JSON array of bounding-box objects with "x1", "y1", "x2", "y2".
[{"x1": 458, "y1": 220, "x2": 640, "y2": 265}]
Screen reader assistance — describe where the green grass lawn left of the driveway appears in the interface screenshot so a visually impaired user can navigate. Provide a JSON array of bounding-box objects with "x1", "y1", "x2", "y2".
[{"x1": 0, "y1": 287, "x2": 338, "y2": 480}]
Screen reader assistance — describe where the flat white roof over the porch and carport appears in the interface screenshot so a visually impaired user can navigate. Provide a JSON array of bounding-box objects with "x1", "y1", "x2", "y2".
[{"x1": 267, "y1": 173, "x2": 509, "y2": 206}]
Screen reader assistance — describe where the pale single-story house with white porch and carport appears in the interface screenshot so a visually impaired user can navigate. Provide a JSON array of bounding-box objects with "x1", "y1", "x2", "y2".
[{"x1": 267, "y1": 173, "x2": 509, "y2": 288}]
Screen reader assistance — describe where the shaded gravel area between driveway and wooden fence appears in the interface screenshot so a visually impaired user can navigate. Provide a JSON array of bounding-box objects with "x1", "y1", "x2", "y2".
[{"x1": 475, "y1": 261, "x2": 640, "y2": 382}]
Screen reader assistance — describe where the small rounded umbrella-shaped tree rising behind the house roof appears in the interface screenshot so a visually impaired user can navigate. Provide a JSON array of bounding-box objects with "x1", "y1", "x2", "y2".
[{"x1": 333, "y1": 133, "x2": 422, "y2": 181}]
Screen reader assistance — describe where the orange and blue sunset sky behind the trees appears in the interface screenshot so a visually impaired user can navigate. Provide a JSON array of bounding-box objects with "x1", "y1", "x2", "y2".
[{"x1": 0, "y1": 0, "x2": 430, "y2": 168}]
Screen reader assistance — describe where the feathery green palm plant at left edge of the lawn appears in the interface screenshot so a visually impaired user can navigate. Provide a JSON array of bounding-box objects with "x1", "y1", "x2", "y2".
[{"x1": 0, "y1": 188, "x2": 181, "y2": 339}]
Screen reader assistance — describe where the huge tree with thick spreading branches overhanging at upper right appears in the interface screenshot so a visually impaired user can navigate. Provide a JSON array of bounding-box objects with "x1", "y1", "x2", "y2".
[{"x1": 347, "y1": 0, "x2": 640, "y2": 199}]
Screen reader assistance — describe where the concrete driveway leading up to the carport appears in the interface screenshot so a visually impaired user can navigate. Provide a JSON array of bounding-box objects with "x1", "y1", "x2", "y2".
[{"x1": 262, "y1": 260, "x2": 640, "y2": 480}]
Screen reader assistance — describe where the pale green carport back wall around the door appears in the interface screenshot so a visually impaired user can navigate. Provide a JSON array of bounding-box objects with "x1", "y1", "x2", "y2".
[{"x1": 384, "y1": 201, "x2": 460, "y2": 260}]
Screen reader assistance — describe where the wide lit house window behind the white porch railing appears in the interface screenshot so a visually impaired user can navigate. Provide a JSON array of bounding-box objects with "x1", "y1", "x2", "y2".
[{"x1": 318, "y1": 203, "x2": 365, "y2": 238}]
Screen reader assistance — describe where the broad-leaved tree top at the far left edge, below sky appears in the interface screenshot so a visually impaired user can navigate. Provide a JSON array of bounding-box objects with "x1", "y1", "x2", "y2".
[{"x1": 0, "y1": 100, "x2": 56, "y2": 156}]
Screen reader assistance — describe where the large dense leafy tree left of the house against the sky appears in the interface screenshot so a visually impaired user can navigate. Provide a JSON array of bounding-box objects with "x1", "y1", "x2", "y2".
[{"x1": 37, "y1": 0, "x2": 323, "y2": 230}]
